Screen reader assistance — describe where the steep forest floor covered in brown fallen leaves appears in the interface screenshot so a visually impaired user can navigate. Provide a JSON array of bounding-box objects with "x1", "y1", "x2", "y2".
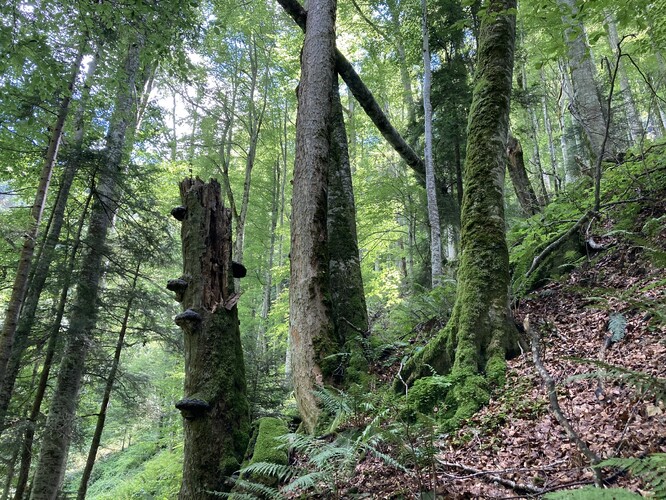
[{"x1": 339, "y1": 198, "x2": 666, "y2": 499}]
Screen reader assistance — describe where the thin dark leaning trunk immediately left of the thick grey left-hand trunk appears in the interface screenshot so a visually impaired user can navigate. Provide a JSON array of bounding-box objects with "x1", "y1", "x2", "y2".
[{"x1": 14, "y1": 190, "x2": 93, "y2": 500}]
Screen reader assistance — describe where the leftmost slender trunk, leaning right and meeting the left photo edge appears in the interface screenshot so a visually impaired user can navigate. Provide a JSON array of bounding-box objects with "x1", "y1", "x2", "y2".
[{"x1": 0, "y1": 42, "x2": 86, "y2": 392}]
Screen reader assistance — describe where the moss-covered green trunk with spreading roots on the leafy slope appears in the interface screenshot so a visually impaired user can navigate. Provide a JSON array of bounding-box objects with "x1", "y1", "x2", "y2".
[{"x1": 396, "y1": 0, "x2": 517, "y2": 425}]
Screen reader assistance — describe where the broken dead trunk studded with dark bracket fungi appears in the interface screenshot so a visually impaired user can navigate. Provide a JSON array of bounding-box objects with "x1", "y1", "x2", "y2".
[{"x1": 167, "y1": 178, "x2": 250, "y2": 500}]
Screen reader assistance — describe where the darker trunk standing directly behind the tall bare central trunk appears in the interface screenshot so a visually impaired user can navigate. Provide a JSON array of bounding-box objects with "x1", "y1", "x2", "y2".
[{"x1": 327, "y1": 77, "x2": 368, "y2": 384}]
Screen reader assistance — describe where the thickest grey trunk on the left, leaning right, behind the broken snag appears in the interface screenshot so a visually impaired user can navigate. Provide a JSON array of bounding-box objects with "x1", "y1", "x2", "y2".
[{"x1": 30, "y1": 36, "x2": 143, "y2": 500}]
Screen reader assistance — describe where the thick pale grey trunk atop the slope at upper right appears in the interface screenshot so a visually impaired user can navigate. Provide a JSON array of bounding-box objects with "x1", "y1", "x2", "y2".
[{"x1": 557, "y1": 0, "x2": 610, "y2": 160}]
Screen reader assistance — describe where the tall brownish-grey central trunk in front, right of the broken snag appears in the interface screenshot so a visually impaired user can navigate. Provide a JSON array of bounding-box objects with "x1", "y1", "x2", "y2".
[{"x1": 289, "y1": 0, "x2": 338, "y2": 432}]
